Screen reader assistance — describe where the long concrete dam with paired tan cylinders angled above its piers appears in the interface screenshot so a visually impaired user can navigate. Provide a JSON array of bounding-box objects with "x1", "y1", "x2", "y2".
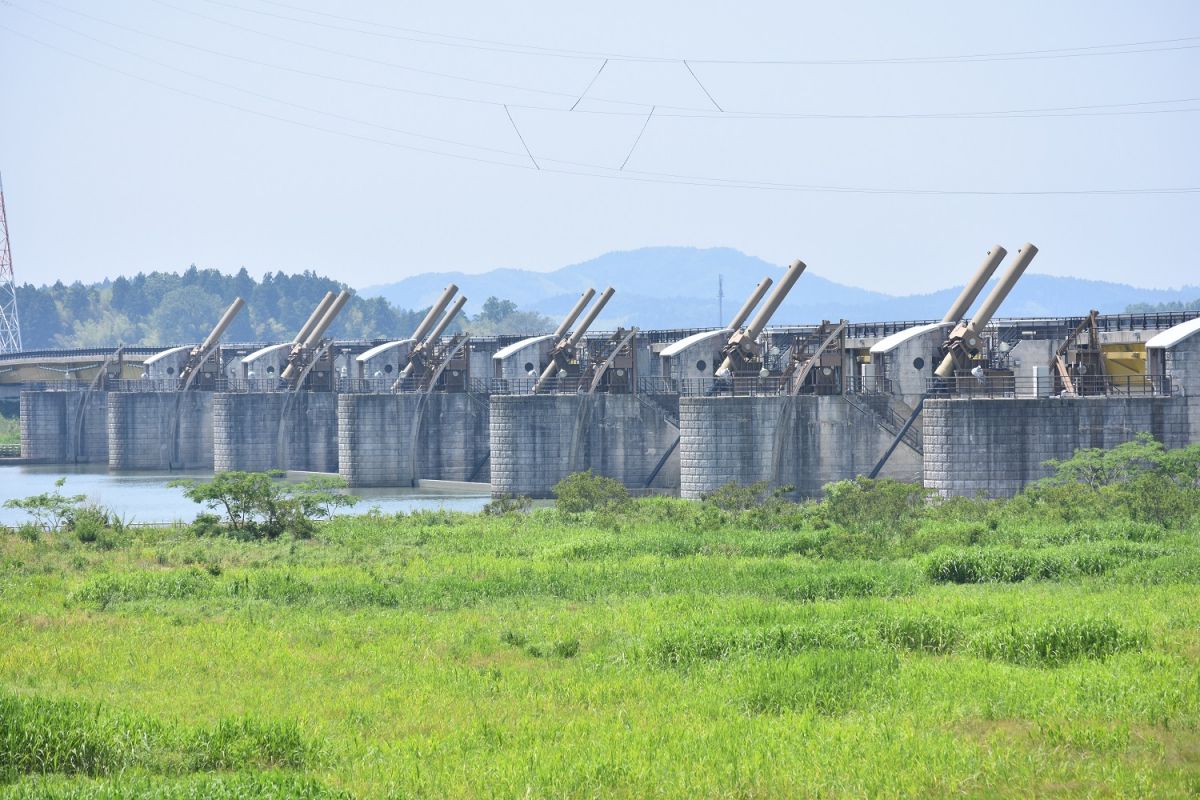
[{"x1": 11, "y1": 243, "x2": 1200, "y2": 499}]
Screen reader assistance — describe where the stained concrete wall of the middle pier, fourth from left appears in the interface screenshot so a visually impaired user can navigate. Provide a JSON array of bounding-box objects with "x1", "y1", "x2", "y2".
[{"x1": 337, "y1": 392, "x2": 490, "y2": 487}]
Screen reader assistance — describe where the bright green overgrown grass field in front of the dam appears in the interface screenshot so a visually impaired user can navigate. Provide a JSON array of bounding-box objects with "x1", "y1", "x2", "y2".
[{"x1": 0, "y1": 479, "x2": 1200, "y2": 798}]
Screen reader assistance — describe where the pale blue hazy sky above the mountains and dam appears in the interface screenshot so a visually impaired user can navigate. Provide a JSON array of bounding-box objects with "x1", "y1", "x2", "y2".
[{"x1": 0, "y1": 0, "x2": 1200, "y2": 293}]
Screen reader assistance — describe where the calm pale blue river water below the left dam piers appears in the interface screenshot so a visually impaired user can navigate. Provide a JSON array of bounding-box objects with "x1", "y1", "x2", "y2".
[{"x1": 0, "y1": 465, "x2": 488, "y2": 525}]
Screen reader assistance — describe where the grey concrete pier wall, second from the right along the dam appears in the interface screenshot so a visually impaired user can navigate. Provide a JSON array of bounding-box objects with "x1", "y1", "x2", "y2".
[{"x1": 679, "y1": 396, "x2": 920, "y2": 499}]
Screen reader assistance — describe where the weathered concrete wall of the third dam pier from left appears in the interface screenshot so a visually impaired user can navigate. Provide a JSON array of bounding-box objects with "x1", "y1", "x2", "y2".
[{"x1": 212, "y1": 392, "x2": 337, "y2": 473}]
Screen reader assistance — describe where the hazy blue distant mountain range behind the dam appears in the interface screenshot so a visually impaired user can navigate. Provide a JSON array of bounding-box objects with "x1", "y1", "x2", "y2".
[{"x1": 359, "y1": 247, "x2": 1200, "y2": 329}]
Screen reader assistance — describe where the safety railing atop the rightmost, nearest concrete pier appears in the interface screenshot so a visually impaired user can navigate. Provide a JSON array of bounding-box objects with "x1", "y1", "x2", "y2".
[{"x1": 926, "y1": 374, "x2": 1171, "y2": 399}]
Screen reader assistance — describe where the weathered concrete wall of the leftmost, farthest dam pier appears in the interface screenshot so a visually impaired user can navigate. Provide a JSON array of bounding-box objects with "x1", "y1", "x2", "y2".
[{"x1": 20, "y1": 390, "x2": 108, "y2": 464}]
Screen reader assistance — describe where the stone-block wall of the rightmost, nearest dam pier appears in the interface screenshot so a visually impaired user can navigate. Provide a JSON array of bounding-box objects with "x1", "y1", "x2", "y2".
[{"x1": 924, "y1": 397, "x2": 1188, "y2": 498}]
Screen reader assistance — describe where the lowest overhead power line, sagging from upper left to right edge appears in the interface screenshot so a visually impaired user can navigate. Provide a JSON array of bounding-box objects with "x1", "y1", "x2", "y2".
[{"x1": 0, "y1": 24, "x2": 1200, "y2": 197}]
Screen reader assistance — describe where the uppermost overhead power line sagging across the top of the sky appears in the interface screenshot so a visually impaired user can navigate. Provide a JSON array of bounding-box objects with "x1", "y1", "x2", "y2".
[{"x1": 196, "y1": 0, "x2": 1200, "y2": 66}]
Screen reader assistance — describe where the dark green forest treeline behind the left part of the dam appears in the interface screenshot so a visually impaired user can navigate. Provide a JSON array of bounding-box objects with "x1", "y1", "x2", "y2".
[{"x1": 17, "y1": 265, "x2": 548, "y2": 350}]
